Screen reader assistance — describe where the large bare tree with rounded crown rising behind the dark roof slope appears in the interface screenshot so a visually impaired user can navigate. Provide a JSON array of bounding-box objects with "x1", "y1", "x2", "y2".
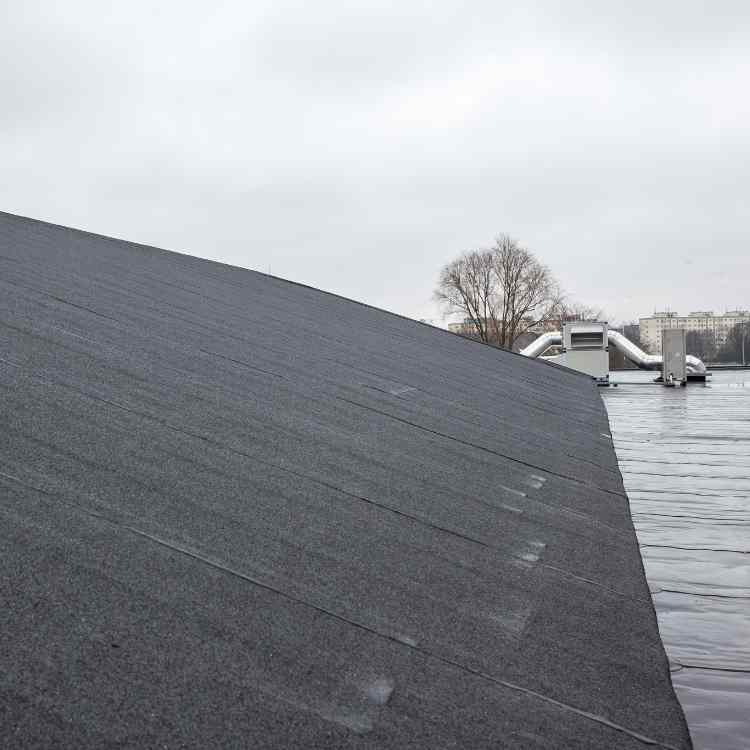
[{"x1": 435, "y1": 235, "x2": 562, "y2": 349}]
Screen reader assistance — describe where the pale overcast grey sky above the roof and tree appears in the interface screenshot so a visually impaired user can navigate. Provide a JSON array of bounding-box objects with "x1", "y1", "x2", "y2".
[{"x1": 0, "y1": 0, "x2": 750, "y2": 321}]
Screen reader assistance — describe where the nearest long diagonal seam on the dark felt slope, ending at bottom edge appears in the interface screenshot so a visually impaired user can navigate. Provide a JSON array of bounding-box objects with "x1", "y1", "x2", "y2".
[{"x1": 0, "y1": 472, "x2": 685, "y2": 750}]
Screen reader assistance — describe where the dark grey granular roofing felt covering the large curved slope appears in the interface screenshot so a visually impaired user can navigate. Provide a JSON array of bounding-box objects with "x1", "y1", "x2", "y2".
[{"x1": 0, "y1": 214, "x2": 689, "y2": 749}]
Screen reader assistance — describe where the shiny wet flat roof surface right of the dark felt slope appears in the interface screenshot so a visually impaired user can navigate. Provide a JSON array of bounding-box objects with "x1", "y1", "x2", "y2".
[{"x1": 604, "y1": 370, "x2": 750, "y2": 750}]
